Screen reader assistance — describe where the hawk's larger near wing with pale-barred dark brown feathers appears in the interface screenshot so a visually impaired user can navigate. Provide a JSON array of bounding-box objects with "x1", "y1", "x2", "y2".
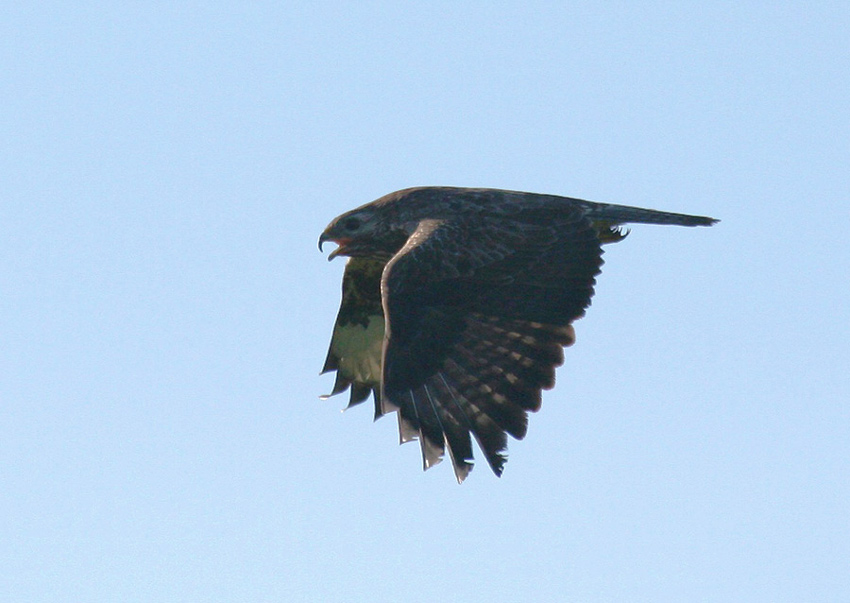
[{"x1": 381, "y1": 208, "x2": 602, "y2": 481}]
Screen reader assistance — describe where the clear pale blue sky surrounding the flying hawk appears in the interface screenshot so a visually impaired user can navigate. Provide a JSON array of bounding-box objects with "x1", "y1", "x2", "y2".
[{"x1": 0, "y1": 1, "x2": 850, "y2": 603}]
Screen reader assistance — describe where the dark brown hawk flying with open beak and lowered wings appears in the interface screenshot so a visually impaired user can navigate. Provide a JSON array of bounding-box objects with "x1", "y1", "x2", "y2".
[{"x1": 319, "y1": 187, "x2": 717, "y2": 483}]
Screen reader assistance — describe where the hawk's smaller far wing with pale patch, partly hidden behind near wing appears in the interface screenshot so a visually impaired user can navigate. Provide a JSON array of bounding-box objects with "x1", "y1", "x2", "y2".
[{"x1": 322, "y1": 258, "x2": 385, "y2": 417}]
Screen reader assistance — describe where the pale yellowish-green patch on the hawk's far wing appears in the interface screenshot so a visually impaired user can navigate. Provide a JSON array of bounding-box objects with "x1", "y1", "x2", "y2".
[{"x1": 331, "y1": 315, "x2": 384, "y2": 386}]
